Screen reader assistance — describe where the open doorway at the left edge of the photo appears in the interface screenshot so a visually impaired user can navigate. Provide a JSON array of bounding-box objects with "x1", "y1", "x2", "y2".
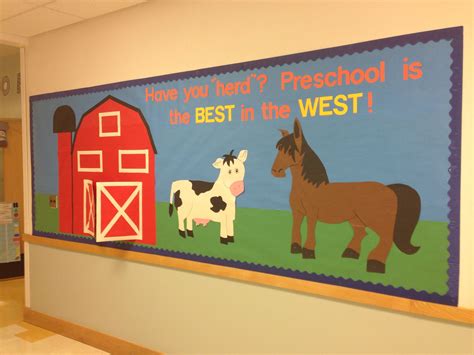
[{"x1": 0, "y1": 44, "x2": 24, "y2": 279}]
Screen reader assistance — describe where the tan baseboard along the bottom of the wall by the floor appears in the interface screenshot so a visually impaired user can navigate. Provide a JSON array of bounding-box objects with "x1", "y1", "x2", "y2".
[{"x1": 23, "y1": 307, "x2": 162, "y2": 355}]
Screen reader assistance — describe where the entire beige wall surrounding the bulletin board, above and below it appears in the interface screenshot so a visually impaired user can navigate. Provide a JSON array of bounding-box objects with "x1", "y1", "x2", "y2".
[{"x1": 26, "y1": 0, "x2": 474, "y2": 353}]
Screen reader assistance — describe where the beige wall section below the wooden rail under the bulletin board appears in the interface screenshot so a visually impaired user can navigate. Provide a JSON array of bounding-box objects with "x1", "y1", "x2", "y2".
[{"x1": 30, "y1": 244, "x2": 473, "y2": 355}]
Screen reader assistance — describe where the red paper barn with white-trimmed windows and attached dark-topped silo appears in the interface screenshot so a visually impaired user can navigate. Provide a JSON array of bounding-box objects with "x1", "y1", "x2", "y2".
[{"x1": 53, "y1": 96, "x2": 156, "y2": 245}]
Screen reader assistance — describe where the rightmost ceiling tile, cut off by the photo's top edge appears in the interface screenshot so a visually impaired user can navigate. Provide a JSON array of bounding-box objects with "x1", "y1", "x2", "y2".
[{"x1": 47, "y1": 0, "x2": 147, "y2": 18}]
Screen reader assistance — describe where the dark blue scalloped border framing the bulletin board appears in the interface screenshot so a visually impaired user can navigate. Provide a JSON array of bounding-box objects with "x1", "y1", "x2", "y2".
[{"x1": 30, "y1": 27, "x2": 463, "y2": 305}]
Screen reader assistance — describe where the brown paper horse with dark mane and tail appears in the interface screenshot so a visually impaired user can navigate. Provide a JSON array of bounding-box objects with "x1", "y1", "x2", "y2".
[{"x1": 272, "y1": 119, "x2": 421, "y2": 273}]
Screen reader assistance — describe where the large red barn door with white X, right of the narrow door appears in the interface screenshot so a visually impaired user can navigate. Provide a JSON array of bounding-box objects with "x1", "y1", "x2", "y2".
[{"x1": 96, "y1": 181, "x2": 143, "y2": 242}]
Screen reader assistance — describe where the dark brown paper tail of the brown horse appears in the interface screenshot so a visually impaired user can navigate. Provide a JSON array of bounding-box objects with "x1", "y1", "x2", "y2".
[{"x1": 387, "y1": 184, "x2": 421, "y2": 255}]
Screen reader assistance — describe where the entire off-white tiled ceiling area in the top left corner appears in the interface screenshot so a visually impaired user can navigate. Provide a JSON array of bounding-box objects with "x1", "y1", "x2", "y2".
[{"x1": 0, "y1": 0, "x2": 148, "y2": 38}]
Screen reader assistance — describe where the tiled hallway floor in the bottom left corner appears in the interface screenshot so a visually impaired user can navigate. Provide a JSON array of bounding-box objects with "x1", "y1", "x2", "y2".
[{"x1": 0, "y1": 279, "x2": 107, "y2": 355}]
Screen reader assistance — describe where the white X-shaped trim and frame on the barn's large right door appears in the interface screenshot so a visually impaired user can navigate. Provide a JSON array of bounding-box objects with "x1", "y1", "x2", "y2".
[{"x1": 95, "y1": 181, "x2": 143, "y2": 242}]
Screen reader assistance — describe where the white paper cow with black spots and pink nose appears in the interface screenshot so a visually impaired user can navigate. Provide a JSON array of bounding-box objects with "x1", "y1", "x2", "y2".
[{"x1": 169, "y1": 150, "x2": 247, "y2": 244}]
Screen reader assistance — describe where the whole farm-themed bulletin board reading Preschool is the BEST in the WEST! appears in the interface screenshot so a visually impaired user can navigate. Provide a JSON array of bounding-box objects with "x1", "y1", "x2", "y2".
[{"x1": 30, "y1": 27, "x2": 463, "y2": 306}]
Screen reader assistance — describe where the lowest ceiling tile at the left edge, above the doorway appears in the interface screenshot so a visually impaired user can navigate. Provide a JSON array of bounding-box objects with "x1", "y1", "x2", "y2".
[{"x1": 0, "y1": 7, "x2": 82, "y2": 37}]
